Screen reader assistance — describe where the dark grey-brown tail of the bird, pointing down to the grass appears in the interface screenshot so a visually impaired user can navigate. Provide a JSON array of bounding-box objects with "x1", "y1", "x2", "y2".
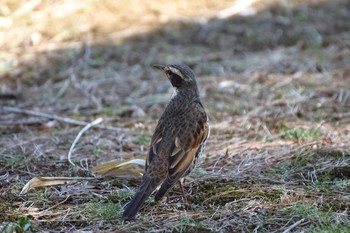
[{"x1": 122, "y1": 177, "x2": 153, "y2": 220}]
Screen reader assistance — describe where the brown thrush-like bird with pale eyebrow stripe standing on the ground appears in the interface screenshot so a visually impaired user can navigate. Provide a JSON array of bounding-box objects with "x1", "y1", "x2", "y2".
[{"x1": 122, "y1": 64, "x2": 210, "y2": 220}]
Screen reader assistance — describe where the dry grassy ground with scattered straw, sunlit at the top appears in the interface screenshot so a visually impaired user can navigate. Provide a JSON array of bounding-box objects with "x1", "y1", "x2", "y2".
[{"x1": 0, "y1": 0, "x2": 350, "y2": 233}]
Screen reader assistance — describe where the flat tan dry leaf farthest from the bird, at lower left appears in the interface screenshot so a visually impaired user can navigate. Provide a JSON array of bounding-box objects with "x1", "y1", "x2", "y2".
[{"x1": 20, "y1": 177, "x2": 95, "y2": 195}]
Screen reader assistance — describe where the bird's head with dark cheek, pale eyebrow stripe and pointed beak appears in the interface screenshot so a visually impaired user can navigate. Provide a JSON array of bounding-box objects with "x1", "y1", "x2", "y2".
[{"x1": 152, "y1": 64, "x2": 197, "y2": 90}]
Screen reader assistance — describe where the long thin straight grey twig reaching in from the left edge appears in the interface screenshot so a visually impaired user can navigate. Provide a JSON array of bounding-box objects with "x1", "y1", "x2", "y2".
[{"x1": 0, "y1": 106, "x2": 127, "y2": 131}]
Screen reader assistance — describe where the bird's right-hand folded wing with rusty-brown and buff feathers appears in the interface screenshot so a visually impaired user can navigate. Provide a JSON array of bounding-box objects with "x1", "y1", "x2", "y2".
[{"x1": 155, "y1": 104, "x2": 209, "y2": 200}]
